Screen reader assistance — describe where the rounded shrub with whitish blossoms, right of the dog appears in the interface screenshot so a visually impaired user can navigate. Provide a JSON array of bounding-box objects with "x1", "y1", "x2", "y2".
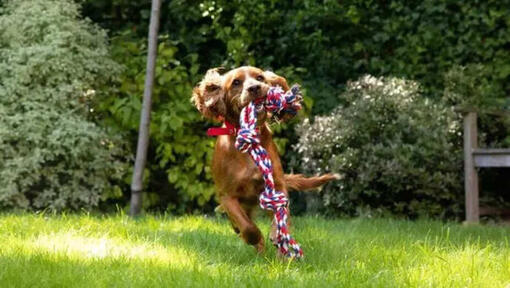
[{"x1": 296, "y1": 76, "x2": 462, "y2": 216}]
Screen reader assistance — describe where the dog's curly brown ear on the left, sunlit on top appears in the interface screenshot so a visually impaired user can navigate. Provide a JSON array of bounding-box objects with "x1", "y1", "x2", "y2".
[{"x1": 191, "y1": 68, "x2": 226, "y2": 119}]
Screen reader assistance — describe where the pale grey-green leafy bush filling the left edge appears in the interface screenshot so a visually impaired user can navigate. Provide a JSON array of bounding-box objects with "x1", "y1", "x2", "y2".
[{"x1": 0, "y1": 0, "x2": 124, "y2": 210}]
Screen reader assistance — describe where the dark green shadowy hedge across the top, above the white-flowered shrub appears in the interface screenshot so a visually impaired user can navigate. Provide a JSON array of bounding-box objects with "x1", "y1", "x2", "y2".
[{"x1": 78, "y1": 0, "x2": 510, "y2": 215}]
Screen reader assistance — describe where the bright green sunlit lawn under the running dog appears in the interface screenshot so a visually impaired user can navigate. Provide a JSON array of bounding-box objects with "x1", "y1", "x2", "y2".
[{"x1": 0, "y1": 214, "x2": 510, "y2": 287}]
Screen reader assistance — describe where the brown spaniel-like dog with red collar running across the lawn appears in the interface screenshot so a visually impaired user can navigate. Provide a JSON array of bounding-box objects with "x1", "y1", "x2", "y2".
[{"x1": 192, "y1": 66, "x2": 338, "y2": 252}]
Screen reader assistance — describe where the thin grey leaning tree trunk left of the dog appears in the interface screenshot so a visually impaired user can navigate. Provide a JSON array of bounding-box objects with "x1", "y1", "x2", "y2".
[{"x1": 129, "y1": 0, "x2": 161, "y2": 217}]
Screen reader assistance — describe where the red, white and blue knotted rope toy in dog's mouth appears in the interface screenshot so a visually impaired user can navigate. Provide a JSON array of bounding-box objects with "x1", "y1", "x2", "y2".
[{"x1": 235, "y1": 85, "x2": 303, "y2": 258}]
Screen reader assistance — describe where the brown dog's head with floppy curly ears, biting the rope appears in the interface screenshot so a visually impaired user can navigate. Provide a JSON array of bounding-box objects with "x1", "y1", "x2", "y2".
[{"x1": 192, "y1": 66, "x2": 289, "y2": 123}]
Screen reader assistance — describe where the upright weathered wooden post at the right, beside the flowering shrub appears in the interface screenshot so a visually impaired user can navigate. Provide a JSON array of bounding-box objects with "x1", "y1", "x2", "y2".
[{"x1": 464, "y1": 112, "x2": 480, "y2": 223}]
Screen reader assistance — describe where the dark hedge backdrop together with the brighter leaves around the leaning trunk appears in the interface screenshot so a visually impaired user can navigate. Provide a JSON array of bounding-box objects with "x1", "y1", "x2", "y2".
[{"x1": 28, "y1": 0, "x2": 510, "y2": 216}]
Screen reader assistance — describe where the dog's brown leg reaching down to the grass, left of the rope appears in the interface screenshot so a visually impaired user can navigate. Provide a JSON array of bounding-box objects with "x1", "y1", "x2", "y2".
[{"x1": 221, "y1": 196, "x2": 264, "y2": 253}]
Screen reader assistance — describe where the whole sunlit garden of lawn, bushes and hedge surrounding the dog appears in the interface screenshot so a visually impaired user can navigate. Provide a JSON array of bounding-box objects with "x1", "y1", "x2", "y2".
[{"x1": 0, "y1": 0, "x2": 510, "y2": 287}]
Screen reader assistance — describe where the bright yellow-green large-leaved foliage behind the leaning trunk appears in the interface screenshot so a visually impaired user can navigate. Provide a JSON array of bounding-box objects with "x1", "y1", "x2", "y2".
[{"x1": 98, "y1": 33, "x2": 214, "y2": 212}]
